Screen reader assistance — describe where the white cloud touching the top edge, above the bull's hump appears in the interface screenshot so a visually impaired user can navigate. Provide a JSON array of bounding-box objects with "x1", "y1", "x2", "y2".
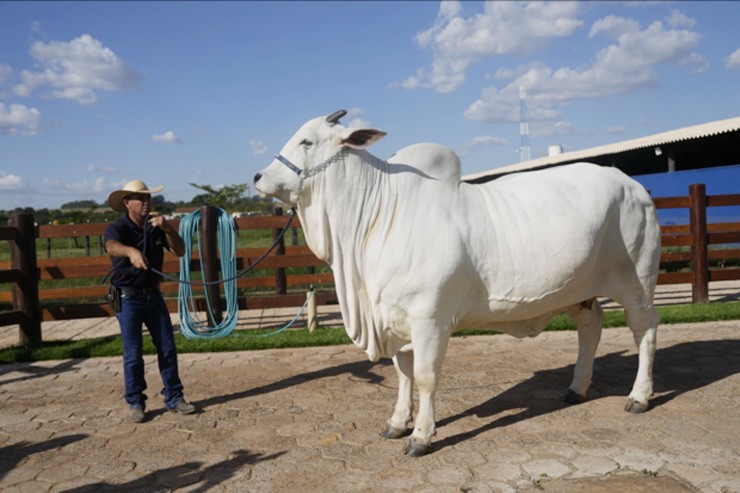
[{"x1": 392, "y1": 1, "x2": 583, "y2": 93}]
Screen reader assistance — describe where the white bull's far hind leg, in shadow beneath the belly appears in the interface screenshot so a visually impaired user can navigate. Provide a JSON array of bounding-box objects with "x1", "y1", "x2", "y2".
[{"x1": 565, "y1": 298, "x2": 604, "y2": 404}]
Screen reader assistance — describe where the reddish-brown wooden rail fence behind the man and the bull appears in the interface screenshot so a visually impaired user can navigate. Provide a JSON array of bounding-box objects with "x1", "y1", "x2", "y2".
[{"x1": 0, "y1": 185, "x2": 740, "y2": 342}]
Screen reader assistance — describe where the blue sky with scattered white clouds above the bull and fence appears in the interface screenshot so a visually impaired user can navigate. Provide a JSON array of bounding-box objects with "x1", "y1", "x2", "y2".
[{"x1": 0, "y1": 0, "x2": 740, "y2": 210}]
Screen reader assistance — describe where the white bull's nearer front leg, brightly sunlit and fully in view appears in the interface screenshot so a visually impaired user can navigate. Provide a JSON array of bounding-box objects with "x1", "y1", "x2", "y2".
[{"x1": 404, "y1": 320, "x2": 450, "y2": 457}]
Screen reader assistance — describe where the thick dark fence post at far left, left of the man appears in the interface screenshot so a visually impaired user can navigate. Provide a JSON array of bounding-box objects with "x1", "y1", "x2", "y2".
[{"x1": 10, "y1": 213, "x2": 41, "y2": 345}]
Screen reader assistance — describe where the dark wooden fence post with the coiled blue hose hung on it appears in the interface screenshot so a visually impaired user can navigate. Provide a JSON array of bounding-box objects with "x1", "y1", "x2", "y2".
[{"x1": 200, "y1": 205, "x2": 226, "y2": 327}]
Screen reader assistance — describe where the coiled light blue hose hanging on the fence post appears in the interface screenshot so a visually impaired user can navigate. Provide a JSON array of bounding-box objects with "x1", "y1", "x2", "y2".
[{"x1": 177, "y1": 208, "x2": 239, "y2": 339}]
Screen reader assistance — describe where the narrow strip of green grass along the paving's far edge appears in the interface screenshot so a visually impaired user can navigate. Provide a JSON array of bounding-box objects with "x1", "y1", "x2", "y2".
[{"x1": 0, "y1": 302, "x2": 740, "y2": 363}]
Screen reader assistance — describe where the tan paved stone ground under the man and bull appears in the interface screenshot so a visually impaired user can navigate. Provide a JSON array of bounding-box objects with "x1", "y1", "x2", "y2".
[{"x1": 0, "y1": 322, "x2": 740, "y2": 493}]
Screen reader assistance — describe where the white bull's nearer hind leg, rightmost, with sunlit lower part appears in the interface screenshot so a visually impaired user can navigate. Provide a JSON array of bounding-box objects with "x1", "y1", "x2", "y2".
[{"x1": 624, "y1": 305, "x2": 660, "y2": 413}]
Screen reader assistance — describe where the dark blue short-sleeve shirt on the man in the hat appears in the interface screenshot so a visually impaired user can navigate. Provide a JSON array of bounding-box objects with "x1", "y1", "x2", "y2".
[{"x1": 105, "y1": 215, "x2": 170, "y2": 288}]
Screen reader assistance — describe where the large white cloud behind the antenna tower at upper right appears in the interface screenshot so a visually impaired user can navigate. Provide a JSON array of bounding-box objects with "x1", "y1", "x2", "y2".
[{"x1": 465, "y1": 16, "x2": 707, "y2": 122}]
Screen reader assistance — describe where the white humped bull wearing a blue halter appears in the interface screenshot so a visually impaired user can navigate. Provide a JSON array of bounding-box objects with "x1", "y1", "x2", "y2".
[{"x1": 255, "y1": 111, "x2": 660, "y2": 456}]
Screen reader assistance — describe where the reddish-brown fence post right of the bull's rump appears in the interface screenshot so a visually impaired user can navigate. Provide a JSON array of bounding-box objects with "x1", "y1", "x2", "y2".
[{"x1": 689, "y1": 184, "x2": 709, "y2": 303}]
